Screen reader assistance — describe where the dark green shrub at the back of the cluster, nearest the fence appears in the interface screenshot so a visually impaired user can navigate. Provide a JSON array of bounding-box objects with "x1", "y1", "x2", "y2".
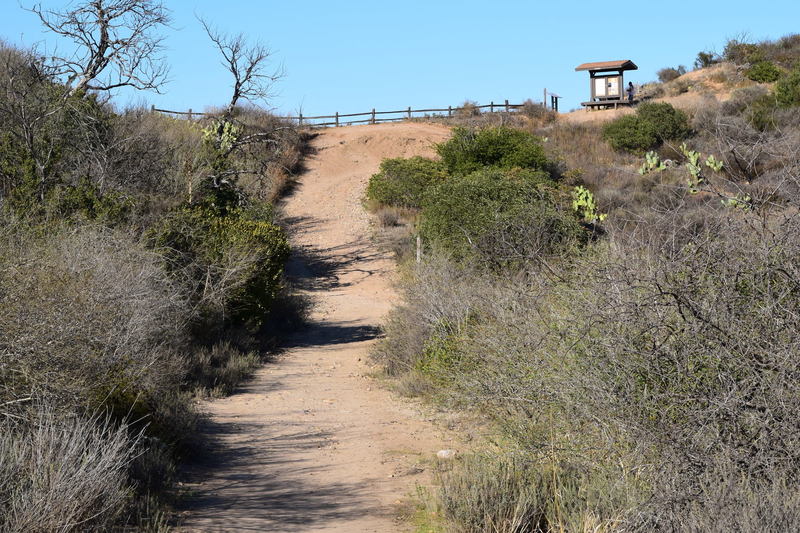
[{"x1": 436, "y1": 126, "x2": 551, "y2": 175}]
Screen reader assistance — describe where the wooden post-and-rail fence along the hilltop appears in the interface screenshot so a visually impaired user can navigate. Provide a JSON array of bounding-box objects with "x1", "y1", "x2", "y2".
[{"x1": 151, "y1": 100, "x2": 547, "y2": 128}]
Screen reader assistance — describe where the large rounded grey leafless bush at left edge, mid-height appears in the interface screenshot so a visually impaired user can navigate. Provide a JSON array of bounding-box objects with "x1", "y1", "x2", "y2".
[{"x1": 0, "y1": 222, "x2": 190, "y2": 414}]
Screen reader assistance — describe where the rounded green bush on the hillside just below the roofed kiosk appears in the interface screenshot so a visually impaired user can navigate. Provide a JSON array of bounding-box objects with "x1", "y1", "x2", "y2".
[{"x1": 603, "y1": 102, "x2": 690, "y2": 152}]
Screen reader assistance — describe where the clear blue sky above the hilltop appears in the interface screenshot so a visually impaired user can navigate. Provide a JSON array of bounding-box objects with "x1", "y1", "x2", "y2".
[{"x1": 0, "y1": 0, "x2": 800, "y2": 116}]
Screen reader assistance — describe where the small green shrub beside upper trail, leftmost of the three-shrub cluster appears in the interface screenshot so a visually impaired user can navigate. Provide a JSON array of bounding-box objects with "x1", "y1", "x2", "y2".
[{"x1": 367, "y1": 156, "x2": 447, "y2": 208}]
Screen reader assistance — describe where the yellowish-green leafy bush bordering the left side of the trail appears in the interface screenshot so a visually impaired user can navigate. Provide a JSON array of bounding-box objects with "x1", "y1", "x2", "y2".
[{"x1": 151, "y1": 206, "x2": 289, "y2": 322}]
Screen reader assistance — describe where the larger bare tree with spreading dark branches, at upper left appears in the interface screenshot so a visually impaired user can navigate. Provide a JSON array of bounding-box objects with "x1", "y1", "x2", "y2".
[{"x1": 30, "y1": 0, "x2": 170, "y2": 96}]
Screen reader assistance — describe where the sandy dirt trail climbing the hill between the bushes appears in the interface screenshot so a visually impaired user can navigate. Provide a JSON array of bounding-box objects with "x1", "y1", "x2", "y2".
[{"x1": 181, "y1": 123, "x2": 458, "y2": 532}]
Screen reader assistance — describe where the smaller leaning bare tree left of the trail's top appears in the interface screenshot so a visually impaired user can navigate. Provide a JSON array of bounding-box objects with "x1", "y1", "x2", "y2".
[{"x1": 200, "y1": 18, "x2": 283, "y2": 117}]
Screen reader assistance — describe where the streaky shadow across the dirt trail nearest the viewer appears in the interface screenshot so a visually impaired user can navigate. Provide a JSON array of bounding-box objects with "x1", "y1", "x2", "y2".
[{"x1": 182, "y1": 421, "x2": 368, "y2": 531}]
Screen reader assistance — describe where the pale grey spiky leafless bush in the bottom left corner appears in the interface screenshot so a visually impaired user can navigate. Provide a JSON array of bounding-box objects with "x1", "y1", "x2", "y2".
[{"x1": 0, "y1": 407, "x2": 136, "y2": 533}]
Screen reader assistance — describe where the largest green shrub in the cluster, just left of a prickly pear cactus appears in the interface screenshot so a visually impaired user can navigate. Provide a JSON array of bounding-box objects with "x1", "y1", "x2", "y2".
[{"x1": 419, "y1": 169, "x2": 583, "y2": 266}]
